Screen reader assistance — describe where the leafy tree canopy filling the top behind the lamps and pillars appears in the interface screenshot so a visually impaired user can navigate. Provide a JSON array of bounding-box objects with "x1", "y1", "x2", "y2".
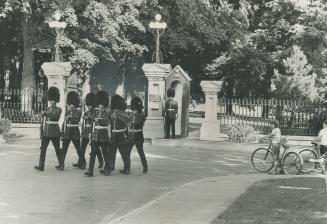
[{"x1": 0, "y1": 0, "x2": 327, "y2": 100}]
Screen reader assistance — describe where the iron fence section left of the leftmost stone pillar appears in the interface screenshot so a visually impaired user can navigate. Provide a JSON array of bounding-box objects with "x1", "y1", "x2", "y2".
[{"x1": 0, "y1": 88, "x2": 47, "y2": 123}]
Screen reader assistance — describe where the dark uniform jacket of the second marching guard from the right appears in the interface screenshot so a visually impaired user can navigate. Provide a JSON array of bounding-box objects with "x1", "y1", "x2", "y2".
[{"x1": 110, "y1": 110, "x2": 128, "y2": 145}]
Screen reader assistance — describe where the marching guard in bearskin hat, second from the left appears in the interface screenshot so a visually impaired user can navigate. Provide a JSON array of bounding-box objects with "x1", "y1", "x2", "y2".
[{"x1": 62, "y1": 91, "x2": 86, "y2": 169}]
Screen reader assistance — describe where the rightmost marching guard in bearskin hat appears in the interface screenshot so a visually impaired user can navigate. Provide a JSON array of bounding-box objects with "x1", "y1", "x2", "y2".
[{"x1": 127, "y1": 97, "x2": 148, "y2": 173}]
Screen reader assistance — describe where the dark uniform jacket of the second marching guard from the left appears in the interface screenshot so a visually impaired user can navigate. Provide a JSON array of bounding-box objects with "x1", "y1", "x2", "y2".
[{"x1": 63, "y1": 108, "x2": 82, "y2": 139}]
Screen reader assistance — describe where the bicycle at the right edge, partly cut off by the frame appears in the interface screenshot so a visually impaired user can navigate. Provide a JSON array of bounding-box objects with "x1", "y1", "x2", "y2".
[{"x1": 299, "y1": 142, "x2": 327, "y2": 173}]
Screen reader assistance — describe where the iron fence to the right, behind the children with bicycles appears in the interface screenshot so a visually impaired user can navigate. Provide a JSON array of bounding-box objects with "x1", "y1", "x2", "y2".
[{"x1": 190, "y1": 98, "x2": 327, "y2": 136}]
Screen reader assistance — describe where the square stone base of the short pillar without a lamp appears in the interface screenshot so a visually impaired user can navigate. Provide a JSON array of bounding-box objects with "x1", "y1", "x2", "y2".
[{"x1": 200, "y1": 121, "x2": 222, "y2": 141}]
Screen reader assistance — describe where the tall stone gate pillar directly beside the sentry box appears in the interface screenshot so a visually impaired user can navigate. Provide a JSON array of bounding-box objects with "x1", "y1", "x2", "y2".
[{"x1": 142, "y1": 63, "x2": 172, "y2": 138}]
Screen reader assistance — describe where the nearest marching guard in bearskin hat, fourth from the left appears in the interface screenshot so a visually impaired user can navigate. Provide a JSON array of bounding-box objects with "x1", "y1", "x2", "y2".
[{"x1": 85, "y1": 91, "x2": 111, "y2": 177}]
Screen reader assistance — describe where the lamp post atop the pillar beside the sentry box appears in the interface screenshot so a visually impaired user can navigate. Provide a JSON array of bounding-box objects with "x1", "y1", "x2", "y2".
[{"x1": 149, "y1": 14, "x2": 167, "y2": 63}]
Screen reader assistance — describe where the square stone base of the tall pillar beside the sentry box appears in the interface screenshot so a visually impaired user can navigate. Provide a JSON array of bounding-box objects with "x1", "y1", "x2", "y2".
[{"x1": 143, "y1": 117, "x2": 165, "y2": 139}]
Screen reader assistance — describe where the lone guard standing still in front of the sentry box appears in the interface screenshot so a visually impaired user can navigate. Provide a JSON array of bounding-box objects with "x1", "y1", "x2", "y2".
[{"x1": 165, "y1": 88, "x2": 178, "y2": 138}]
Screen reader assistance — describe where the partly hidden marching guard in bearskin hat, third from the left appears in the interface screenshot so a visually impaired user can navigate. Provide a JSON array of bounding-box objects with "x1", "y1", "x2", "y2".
[{"x1": 73, "y1": 93, "x2": 103, "y2": 168}]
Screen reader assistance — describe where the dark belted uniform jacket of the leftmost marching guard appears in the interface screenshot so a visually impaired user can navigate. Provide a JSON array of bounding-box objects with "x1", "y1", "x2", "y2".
[{"x1": 42, "y1": 106, "x2": 62, "y2": 138}]
